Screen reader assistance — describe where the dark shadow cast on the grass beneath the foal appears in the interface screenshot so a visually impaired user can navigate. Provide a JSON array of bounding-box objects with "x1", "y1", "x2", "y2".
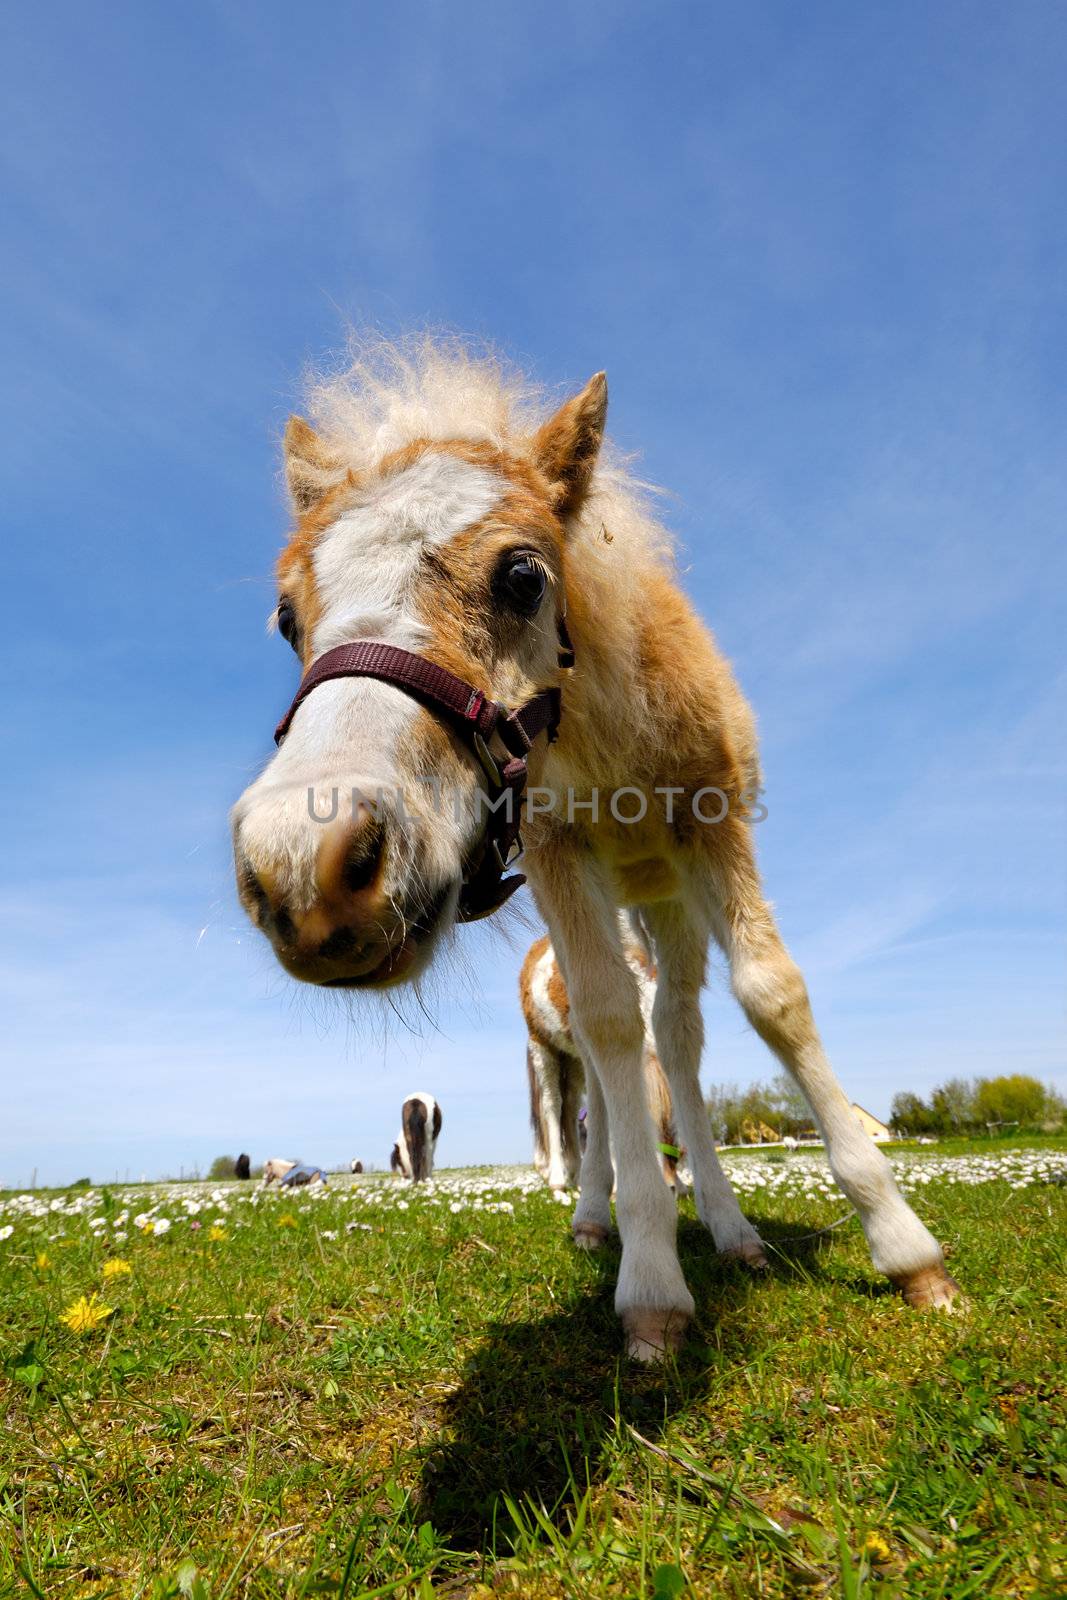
[{"x1": 419, "y1": 1219, "x2": 817, "y2": 1549}]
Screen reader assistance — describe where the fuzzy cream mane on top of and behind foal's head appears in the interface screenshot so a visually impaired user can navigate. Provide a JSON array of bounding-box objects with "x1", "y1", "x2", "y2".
[{"x1": 304, "y1": 333, "x2": 673, "y2": 588}]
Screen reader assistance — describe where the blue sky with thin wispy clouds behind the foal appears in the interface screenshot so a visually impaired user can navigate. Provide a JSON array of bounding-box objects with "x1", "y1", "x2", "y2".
[{"x1": 0, "y1": 0, "x2": 1067, "y2": 1182}]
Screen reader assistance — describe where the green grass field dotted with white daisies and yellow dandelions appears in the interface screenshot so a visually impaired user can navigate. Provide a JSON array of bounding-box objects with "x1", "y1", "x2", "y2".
[{"x1": 0, "y1": 1141, "x2": 1067, "y2": 1600}]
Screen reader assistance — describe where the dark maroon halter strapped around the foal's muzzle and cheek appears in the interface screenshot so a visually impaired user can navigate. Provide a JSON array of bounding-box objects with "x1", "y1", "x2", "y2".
[{"x1": 274, "y1": 618, "x2": 574, "y2": 922}]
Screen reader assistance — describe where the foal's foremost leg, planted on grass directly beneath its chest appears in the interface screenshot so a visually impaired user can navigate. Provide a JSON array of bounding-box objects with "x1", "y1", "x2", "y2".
[{"x1": 530, "y1": 842, "x2": 693, "y2": 1360}]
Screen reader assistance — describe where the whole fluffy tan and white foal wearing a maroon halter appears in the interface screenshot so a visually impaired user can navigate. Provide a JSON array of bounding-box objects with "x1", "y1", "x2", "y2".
[{"x1": 232, "y1": 341, "x2": 957, "y2": 1358}]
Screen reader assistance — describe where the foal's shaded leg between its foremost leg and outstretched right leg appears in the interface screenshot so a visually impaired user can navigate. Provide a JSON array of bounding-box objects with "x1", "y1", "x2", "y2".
[{"x1": 641, "y1": 901, "x2": 768, "y2": 1269}]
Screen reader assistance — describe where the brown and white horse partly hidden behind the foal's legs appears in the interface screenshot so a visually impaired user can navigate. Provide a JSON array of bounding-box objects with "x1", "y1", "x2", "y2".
[{"x1": 518, "y1": 918, "x2": 681, "y2": 1196}]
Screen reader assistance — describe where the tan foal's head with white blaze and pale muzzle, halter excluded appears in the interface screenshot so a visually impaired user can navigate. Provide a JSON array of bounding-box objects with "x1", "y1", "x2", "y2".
[{"x1": 232, "y1": 350, "x2": 606, "y2": 989}]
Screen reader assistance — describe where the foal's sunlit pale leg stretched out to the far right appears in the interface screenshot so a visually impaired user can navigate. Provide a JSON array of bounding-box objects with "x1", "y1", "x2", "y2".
[{"x1": 712, "y1": 819, "x2": 960, "y2": 1306}]
